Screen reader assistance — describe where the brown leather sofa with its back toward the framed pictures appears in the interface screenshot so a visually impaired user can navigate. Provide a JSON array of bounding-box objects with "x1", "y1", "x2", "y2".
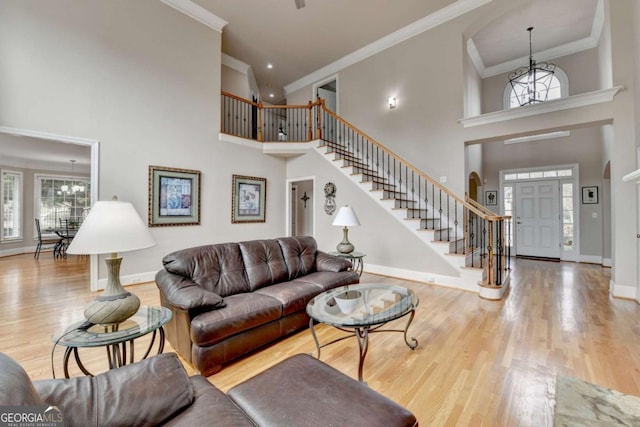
[{"x1": 156, "y1": 237, "x2": 359, "y2": 376}]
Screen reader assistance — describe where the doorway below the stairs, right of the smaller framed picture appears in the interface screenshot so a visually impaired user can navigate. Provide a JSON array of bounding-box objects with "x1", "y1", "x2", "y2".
[{"x1": 287, "y1": 178, "x2": 315, "y2": 236}]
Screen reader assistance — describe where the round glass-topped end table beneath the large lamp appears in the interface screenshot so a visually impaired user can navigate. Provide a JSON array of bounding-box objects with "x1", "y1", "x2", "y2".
[{"x1": 51, "y1": 305, "x2": 172, "y2": 378}]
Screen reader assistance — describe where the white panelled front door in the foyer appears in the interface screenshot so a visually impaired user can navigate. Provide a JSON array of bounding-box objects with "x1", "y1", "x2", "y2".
[{"x1": 515, "y1": 180, "x2": 560, "y2": 258}]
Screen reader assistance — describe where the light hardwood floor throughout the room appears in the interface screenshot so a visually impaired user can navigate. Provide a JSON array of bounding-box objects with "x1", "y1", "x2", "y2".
[{"x1": 0, "y1": 253, "x2": 640, "y2": 426}]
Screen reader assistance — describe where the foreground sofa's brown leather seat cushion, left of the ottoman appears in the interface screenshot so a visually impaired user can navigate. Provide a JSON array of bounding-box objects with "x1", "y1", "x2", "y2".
[{"x1": 163, "y1": 375, "x2": 255, "y2": 427}]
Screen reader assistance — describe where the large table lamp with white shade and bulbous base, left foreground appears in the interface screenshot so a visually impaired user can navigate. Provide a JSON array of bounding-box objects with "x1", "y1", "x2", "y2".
[{"x1": 67, "y1": 197, "x2": 155, "y2": 325}]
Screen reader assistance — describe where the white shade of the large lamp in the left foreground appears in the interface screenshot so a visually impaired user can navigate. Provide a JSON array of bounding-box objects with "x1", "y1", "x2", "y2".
[{"x1": 67, "y1": 200, "x2": 156, "y2": 254}]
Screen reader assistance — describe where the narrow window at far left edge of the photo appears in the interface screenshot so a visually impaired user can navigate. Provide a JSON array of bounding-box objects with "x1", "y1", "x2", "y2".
[{"x1": 0, "y1": 171, "x2": 22, "y2": 241}]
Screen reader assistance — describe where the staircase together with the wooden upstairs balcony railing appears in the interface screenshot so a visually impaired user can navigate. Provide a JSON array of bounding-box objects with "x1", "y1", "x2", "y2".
[{"x1": 221, "y1": 92, "x2": 511, "y2": 299}]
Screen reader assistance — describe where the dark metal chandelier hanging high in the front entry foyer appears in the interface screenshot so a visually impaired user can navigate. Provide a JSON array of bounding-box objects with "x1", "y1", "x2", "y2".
[{"x1": 509, "y1": 27, "x2": 556, "y2": 106}]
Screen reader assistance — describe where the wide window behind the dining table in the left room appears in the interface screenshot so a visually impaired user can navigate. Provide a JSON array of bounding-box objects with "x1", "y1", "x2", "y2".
[{"x1": 35, "y1": 175, "x2": 91, "y2": 229}]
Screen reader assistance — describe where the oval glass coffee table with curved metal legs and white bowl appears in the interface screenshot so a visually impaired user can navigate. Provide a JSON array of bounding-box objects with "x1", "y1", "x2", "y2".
[{"x1": 307, "y1": 283, "x2": 419, "y2": 381}]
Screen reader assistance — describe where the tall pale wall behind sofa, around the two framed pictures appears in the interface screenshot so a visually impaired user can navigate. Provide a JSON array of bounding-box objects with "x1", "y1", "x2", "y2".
[{"x1": 0, "y1": 0, "x2": 285, "y2": 288}]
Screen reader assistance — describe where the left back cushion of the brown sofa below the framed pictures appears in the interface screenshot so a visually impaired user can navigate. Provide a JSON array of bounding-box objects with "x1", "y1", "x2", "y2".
[{"x1": 162, "y1": 243, "x2": 249, "y2": 297}]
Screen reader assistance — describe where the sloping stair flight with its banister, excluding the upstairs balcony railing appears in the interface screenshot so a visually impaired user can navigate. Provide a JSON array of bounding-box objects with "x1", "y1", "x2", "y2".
[{"x1": 316, "y1": 100, "x2": 510, "y2": 299}]
